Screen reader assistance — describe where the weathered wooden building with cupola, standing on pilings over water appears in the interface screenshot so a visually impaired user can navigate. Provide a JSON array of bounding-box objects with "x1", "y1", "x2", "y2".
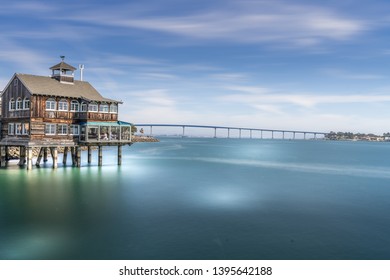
[{"x1": 0, "y1": 57, "x2": 132, "y2": 169}]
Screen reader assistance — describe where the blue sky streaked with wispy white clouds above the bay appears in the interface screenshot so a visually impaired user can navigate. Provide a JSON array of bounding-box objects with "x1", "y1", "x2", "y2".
[{"x1": 0, "y1": 0, "x2": 390, "y2": 134}]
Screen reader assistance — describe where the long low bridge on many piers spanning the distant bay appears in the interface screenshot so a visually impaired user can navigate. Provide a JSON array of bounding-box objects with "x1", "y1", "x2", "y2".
[{"x1": 134, "y1": 123, "x2": 328, "y2": 139}]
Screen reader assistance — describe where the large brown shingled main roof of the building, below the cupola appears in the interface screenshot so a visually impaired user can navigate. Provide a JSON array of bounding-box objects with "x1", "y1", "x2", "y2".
[{"x1": 16, "y1": 74, "x2": 121, "y2": 103}]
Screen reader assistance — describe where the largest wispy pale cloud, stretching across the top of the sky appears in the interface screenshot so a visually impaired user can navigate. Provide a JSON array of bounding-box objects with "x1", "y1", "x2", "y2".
[{"x1": 61, "y1": 1, "x2": 369, "y2": 46}]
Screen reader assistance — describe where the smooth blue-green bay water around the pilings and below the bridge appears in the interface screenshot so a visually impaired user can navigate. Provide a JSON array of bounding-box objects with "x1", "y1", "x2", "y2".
[{"x1": 0, "y1": 138, "x2": 390, "y2": 259}]
